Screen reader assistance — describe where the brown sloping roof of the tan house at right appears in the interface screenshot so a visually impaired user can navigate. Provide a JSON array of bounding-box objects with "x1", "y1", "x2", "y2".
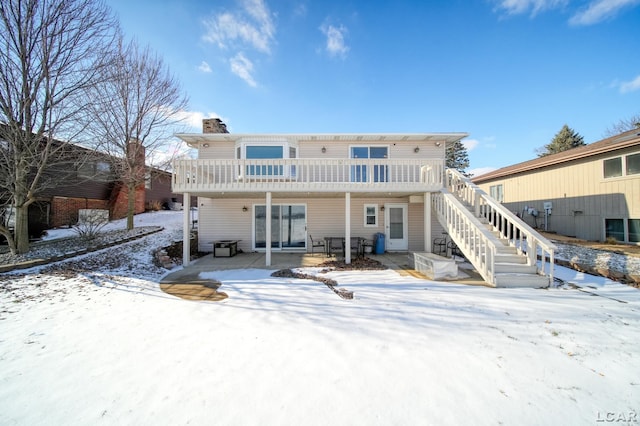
[{"x1": 471, "y1": 129, "x2": 640, "y2": 184}]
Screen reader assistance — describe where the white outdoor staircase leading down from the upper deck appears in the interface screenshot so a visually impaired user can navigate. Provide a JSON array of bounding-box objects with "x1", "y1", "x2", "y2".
[{"x1": 432, "y1": 169, "x2": 555, "y2": 288}]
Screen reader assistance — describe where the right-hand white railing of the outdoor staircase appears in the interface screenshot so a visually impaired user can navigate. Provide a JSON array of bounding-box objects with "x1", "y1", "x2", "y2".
[{"x1": 446, "y1": 169, "x2": 556, "y2": 282}]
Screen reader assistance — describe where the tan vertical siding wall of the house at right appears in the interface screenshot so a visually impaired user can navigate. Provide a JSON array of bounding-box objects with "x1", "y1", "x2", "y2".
[{"x1": 478, "y1": 147, "x2": 640, "y2": 240}]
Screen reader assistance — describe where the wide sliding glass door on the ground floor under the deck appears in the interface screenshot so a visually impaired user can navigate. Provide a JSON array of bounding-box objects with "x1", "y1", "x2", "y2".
[{"x1": 253, "y1": 204, "x2": 307, "y2": 250}]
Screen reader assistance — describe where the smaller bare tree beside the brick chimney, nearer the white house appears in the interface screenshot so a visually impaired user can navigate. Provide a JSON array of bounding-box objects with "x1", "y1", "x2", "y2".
[{"x1": 85, "y1": 35, "x2": 187, "y2": 229}]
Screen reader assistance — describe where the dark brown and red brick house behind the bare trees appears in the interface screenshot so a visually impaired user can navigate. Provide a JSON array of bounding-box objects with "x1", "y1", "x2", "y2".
[{"x1": 5, "y1": 135, "x2": 188, "y2": 238}]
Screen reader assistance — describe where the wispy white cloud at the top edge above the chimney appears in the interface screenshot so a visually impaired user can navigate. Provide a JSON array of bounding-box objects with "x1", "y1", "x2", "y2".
[{"x1": 202, "y1": 0, "x2": 276, "y2": 54}]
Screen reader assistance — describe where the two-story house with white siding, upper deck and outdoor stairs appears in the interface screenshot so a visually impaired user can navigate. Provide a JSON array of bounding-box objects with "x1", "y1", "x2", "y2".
[{"x1": 173, "y1": 119, "x2": 552, "y2": 285}]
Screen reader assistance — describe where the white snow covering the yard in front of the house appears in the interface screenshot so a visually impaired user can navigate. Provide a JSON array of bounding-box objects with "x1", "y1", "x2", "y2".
[{"x1": 0, "y1": 212, "x2": 640, "y2": 425}]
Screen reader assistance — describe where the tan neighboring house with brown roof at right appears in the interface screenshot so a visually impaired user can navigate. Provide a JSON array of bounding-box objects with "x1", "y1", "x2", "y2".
[{"x1": 472, "y1": 129, "x2": 640, "y2": 244}]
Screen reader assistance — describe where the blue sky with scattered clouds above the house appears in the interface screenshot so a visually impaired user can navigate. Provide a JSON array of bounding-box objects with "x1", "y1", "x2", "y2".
[{"x1": 107, "y1": 0, "x2": 640, "y2": 175}]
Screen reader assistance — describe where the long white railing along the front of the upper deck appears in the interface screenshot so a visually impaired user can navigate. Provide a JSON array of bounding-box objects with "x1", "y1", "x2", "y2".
[{"x1": 172, "y1": 159, "x2": 444, "y2": 193}]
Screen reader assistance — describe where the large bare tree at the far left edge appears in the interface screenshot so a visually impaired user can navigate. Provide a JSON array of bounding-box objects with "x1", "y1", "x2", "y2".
[{"x1": 0, "y1": 0, "x2": 115, "y2": 253}]
